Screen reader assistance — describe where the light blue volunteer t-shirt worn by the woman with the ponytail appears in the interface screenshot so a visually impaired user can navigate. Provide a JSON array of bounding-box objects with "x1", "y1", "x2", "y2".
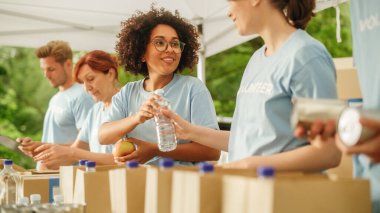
[{"x1": 228, "y1": 30, "x2": 337, "y2": 161}]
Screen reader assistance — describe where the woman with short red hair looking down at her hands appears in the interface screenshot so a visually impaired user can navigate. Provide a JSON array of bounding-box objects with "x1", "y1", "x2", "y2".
[{"x1": 34, "y1": 50, "x2": 119, "y2": 169}]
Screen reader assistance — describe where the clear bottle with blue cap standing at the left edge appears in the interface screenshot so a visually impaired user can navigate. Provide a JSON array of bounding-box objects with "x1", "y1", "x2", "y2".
[{"x1": 0, "y1": 160, "x2": 22, "y2": 205}]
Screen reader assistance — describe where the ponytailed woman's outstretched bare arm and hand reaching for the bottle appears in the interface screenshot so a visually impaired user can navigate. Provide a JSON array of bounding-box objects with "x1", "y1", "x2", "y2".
[{"x1": 162, "y1": 109, "x2": 230, "y2": 151}]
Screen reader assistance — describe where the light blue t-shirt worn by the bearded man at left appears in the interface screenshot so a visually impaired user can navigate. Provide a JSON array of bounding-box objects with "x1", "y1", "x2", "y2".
[{"x1": 41, "y1": 83, "x2": 94, "y2": 144}]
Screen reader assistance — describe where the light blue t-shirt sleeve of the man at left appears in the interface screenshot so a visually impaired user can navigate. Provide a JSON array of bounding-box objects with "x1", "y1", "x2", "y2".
[{"x1": 73, "y1": 93, "x2": 94, "y2": 130}]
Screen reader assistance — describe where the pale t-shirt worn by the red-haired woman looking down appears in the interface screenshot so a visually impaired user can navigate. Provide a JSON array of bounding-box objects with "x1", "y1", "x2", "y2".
[{"x1": 78, "y1": 102, "x2": 113, "y2": 153}]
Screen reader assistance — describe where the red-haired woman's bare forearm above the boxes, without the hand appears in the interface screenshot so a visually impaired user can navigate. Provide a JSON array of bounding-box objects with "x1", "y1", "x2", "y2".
[{"x1": 71, "y1": 148, "x2": 115, "y2": 165}]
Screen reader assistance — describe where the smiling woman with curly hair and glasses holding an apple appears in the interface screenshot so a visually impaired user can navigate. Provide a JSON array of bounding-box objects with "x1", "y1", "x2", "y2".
[{"x1": 99, "y1": 5, "x2": 220, "y2": 165}]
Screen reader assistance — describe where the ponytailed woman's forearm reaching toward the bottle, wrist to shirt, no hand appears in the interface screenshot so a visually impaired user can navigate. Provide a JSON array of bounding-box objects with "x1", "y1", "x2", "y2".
[{"x1": 190, "y1": 125, "x2": 230, "y2": 152}]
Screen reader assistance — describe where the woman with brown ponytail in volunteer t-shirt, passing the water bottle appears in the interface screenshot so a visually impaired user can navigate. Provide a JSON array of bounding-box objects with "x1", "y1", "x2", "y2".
[{"x1": 164, "y1": 0, "x2": 340, "y2": 171}]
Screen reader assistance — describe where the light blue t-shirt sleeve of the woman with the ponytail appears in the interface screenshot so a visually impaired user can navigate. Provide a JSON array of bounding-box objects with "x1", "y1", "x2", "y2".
[{"x1": 290, "y1": 57, "x2": 337, "y2": 99}]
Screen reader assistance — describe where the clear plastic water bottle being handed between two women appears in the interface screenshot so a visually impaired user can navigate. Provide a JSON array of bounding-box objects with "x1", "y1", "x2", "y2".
[{"x1": 154, "y1": 89, "x2": 177, "y2": 152}]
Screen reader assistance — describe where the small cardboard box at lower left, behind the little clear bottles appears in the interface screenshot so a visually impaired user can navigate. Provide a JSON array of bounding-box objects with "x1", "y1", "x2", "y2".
[{"x1": 21, "y1": 174, "x2": 60, "y2": 203}]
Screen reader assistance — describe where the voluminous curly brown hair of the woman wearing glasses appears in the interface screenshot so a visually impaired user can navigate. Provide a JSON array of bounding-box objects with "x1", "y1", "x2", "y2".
[{"x1": 116, "y1": 6, "x2": 200, "y2": 77}]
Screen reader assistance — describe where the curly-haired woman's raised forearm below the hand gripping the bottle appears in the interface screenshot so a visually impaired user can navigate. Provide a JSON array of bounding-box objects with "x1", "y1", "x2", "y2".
[{"x1": 99, "y1": 116, "x2": 139, "y2": 145}]
